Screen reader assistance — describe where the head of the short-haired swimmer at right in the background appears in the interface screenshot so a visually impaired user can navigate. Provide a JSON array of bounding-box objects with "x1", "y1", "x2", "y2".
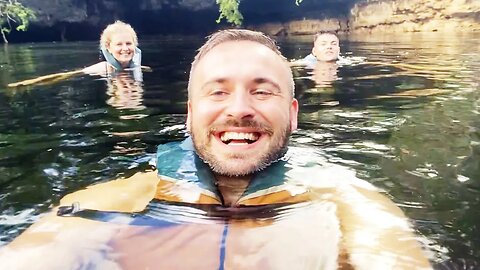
[{"x1": 312, "y1": 31, "x2": 340, "y2": 62}]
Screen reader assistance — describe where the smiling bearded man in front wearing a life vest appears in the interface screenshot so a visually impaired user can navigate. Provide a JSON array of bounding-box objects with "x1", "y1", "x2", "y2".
[{"x1": 0, "y1": 29, "x2": 430, "y2": 270}]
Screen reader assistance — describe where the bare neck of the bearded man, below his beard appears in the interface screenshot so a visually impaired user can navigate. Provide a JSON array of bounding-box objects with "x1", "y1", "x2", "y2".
[{"x1": 215, "y1": 175, "x2": 252, "y2": 206}]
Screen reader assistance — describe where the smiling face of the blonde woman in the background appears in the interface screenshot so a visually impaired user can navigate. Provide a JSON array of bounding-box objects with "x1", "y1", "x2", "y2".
[{"x1": 107, "y1": 33, "x2": 135, "y2": 67}]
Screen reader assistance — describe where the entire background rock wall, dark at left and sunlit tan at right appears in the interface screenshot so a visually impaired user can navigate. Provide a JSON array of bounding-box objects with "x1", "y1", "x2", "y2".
[{"x1": 11, "y1": 0, "x2": 480, "y2": 41}]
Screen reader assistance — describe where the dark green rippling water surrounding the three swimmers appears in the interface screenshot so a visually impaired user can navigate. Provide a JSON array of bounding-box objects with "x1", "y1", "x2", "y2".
[{"x1": 0, "y1": 34, "x2": 480, "y2": 262}]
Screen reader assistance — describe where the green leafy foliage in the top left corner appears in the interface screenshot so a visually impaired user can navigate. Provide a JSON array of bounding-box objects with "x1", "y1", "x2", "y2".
[{"x1": 0, "y1": 0, "x2": 36, "y2": 43}]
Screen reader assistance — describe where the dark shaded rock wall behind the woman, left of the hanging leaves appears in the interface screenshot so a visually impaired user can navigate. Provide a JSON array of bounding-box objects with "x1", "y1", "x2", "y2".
[{"x1": 8, "y1": 0, "x2": 223, "y2": 42}]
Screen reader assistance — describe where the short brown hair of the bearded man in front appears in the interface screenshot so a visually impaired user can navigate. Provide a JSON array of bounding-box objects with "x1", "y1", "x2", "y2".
[{"x1": 188, "y1": 29, "x2": 295, "y2": 97}]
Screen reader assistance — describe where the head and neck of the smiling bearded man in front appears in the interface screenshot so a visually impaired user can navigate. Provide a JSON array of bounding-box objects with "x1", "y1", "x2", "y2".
[{"x1": 187, "y1": 30, "x2": 298, "y2": 205}]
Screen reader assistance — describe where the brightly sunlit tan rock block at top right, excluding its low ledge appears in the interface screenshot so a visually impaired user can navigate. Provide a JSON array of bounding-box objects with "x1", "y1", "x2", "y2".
[{"x1": 349, "y1": 0, "x2": 480, "y2": 32}]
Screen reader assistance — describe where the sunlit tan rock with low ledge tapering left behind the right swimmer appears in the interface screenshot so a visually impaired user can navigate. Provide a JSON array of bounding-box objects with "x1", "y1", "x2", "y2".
[{"x1": 257, "y1": 0, "x2": 480, "y2": 35}]
